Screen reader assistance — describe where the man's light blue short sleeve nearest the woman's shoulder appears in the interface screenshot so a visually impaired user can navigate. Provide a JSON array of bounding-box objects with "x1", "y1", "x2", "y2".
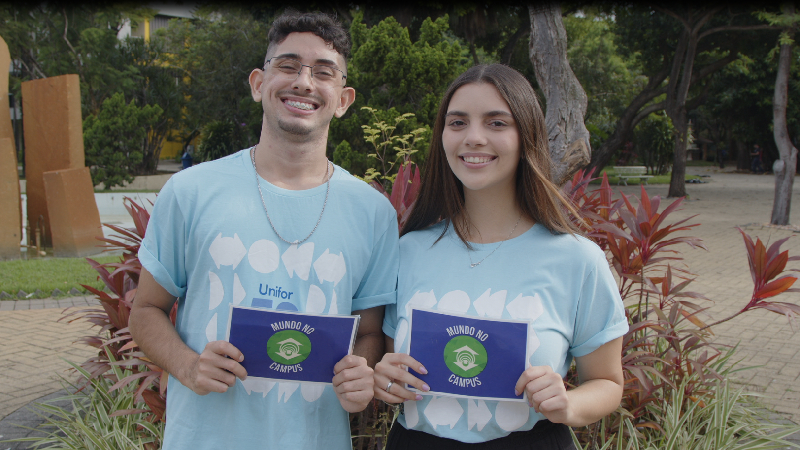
[{"x1": 353, "y1": 210, "x2": 400, "y2": 311}]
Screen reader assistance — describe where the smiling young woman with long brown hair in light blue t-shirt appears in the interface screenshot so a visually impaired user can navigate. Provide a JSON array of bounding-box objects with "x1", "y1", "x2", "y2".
[{"x1": 374, "y1": 64, "x2": 628, "y2": 450}]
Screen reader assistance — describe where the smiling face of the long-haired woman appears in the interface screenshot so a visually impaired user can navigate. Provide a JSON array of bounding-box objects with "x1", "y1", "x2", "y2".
[{"x1": 442, "y1": 83, "x2": 520, "y2": 194}]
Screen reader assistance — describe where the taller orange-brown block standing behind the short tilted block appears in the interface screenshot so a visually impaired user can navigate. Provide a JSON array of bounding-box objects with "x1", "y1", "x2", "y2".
[{"x1": 20, "y1": 75, "x2": 84, "y2": 246}]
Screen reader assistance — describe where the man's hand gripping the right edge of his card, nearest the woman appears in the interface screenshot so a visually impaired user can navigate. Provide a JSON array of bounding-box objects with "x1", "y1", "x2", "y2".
[{"x1": 333, "y1": 355, "x2": 373, "y2": 413}]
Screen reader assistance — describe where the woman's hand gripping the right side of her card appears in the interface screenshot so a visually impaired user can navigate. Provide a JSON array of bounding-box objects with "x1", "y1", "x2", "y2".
[{"x1": 514, "y1": 366, "x2": 571, "y2": 423}]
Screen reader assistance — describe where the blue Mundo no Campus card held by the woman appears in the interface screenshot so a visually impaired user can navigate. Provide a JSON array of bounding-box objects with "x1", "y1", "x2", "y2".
[{"x1": 409, "y1": 309, "x2": 528, "y2": 401}]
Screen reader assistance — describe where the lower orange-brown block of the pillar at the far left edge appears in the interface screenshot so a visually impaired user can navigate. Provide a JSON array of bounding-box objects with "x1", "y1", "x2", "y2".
[{"x1": 0, "y1": 138, "x2": 22, "y2": 260}]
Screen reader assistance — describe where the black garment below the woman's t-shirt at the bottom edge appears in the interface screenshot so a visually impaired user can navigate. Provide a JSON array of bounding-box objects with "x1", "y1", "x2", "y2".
[{"x1": 386, "y1": 420, "x2": 576, "y2": 450}]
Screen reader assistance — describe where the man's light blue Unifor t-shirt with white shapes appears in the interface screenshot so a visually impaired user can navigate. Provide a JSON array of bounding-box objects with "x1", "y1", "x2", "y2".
[{"x1": 139, "y1": 150, "x2": 398, "y2": 450}]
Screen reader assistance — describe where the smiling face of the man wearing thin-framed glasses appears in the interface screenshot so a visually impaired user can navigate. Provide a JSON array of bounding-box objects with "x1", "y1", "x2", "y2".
[{"x1": 250, "y1": 33, "x2": 355, "y2": 140}]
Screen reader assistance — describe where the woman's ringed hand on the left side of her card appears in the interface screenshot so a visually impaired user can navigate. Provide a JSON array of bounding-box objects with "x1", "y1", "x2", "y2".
[{"x1": 372, "y1": 353, "x2": 431, "y2": 403}]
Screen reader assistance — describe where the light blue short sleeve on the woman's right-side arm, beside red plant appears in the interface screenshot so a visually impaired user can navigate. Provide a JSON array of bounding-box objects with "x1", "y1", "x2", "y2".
[{"x1": 570, "y1": 249, "x2": 628, "y2": 357}]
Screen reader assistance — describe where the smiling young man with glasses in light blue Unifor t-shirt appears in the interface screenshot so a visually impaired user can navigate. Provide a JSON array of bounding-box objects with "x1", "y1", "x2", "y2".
[{"x1": 130, "y1": 13, "x2": 398, "y2": 450}]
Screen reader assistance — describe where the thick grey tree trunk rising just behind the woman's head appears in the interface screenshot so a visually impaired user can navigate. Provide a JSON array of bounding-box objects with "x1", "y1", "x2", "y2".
[{"x1": 528, "y1": 2, "x2": 591, "y2": 185}]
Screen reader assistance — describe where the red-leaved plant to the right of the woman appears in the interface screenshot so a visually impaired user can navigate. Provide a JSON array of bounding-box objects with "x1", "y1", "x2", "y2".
[{"x1": 564, "y1": 171, "x2": 800, "y2": 448}]
